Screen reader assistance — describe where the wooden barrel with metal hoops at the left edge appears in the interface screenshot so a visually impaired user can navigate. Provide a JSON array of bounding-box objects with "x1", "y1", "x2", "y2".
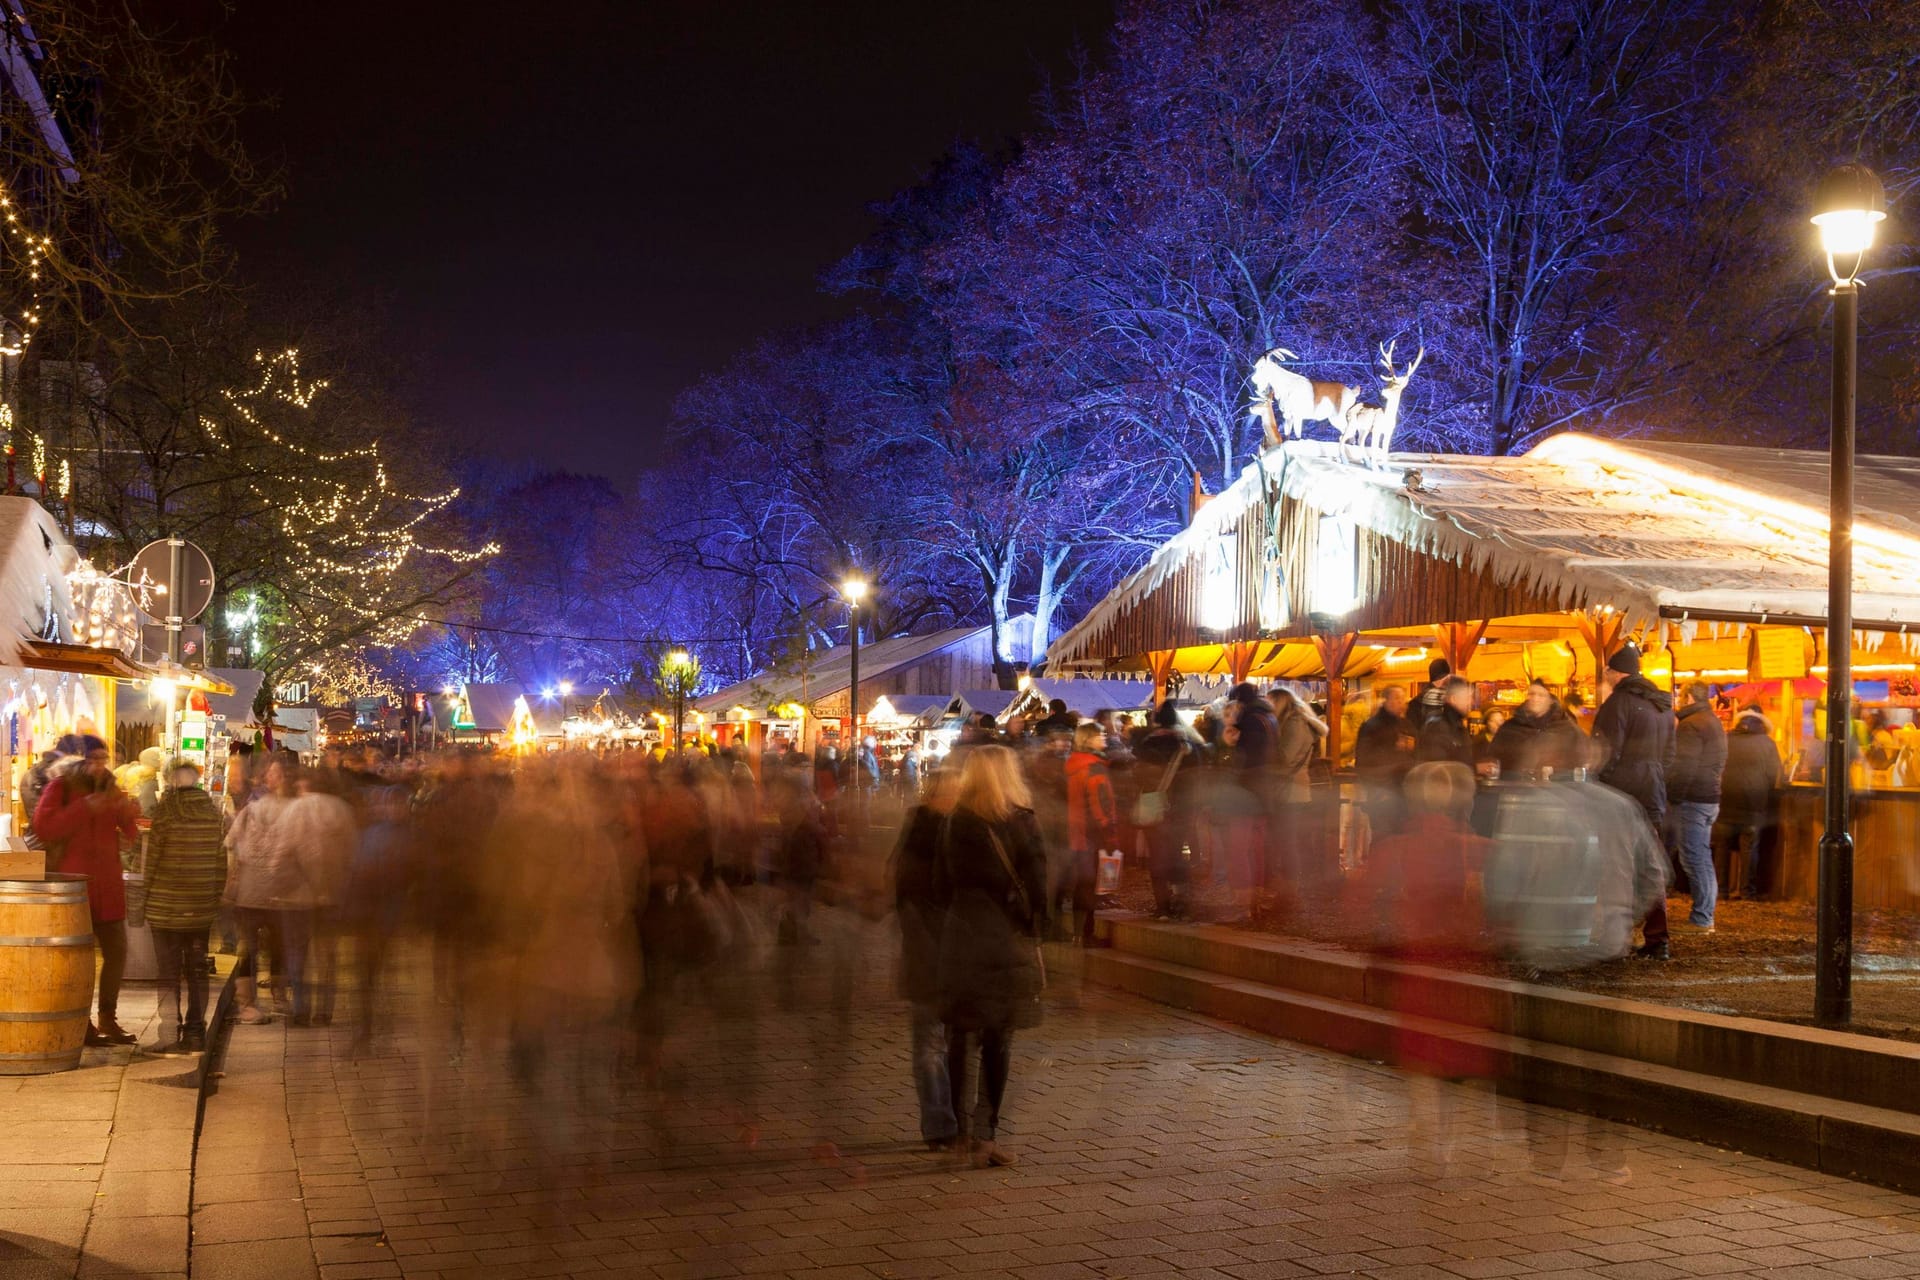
[{"x1": 0, "y1": 873, "x2": 94, "y2": 1075}]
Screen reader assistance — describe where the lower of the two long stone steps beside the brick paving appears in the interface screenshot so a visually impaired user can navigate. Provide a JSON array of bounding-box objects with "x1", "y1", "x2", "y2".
[{"x1": 1085, "y1": 950, "x2": 1920, "y2": 1192}]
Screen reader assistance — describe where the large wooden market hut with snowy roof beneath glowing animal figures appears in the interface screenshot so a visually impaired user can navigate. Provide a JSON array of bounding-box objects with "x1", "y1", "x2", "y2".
[{"x1": 1048, "y1": 434, "x2": 1920, "y2": 908}]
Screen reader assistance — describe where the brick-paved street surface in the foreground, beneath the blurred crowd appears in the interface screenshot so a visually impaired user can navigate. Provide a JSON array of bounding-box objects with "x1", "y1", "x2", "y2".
[{"x1": 224, "y1": 912, "x2": 1920, "y2": 1280}]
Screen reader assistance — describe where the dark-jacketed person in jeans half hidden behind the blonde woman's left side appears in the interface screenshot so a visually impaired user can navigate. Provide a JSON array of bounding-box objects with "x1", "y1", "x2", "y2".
[{"x1": 893, "y1": 770, "x2": 960, "y2": 1151}]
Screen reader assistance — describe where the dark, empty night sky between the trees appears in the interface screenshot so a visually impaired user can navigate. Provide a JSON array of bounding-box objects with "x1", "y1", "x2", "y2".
[{"x1": 191, "y1": 0, "x2": 1112, "y2": 480}]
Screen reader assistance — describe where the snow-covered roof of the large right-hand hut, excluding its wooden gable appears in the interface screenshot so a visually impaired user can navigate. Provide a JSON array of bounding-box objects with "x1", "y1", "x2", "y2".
[{"x1": 1048, "y1": 434, "x2": 1920, "y2": 670}]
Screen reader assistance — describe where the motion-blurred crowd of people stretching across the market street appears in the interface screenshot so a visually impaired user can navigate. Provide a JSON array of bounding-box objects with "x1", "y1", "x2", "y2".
[{"x1": 21, "y1": 649, "x2": 1780, "y2": 1165}]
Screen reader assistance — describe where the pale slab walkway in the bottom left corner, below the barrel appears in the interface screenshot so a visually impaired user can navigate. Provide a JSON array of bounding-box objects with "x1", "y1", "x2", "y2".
[{"x1": 0, "y1": 986, "x2": 200, "y2": 1280}]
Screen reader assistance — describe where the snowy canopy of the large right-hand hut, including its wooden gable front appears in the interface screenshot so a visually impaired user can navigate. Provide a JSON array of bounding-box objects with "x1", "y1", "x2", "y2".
[{"x1": 1048, "y1": 434, "x2": 1920, "y2": 670}]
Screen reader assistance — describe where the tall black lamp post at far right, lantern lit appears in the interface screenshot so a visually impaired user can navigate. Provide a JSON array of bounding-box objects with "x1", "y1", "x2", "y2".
[{"x1": 1812, "y1": 165, "x2": 1887, "y2": 1023}]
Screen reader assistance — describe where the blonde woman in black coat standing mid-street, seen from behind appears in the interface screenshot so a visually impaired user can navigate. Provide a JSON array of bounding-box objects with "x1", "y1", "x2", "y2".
[{"x1": 933, "y1": 747, "x2": 1046, "y2": 1169}]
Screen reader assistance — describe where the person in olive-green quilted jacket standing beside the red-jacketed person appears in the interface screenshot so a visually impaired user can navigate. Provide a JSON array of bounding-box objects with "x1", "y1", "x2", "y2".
[{"x1": 146, "y1": 756, "x2": 227, "y2": 1054}]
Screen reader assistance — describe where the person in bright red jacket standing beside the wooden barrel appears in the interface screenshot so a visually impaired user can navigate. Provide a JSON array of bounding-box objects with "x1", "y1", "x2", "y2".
[{"x1": 33, "y1": 733, "x2": 140, "y2": 1046}]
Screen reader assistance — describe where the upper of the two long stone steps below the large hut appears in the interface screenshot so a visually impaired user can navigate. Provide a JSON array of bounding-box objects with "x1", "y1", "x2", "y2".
[{"x1": 1100, "y1": 917, "x2": 1920, "y2": 1113}]
